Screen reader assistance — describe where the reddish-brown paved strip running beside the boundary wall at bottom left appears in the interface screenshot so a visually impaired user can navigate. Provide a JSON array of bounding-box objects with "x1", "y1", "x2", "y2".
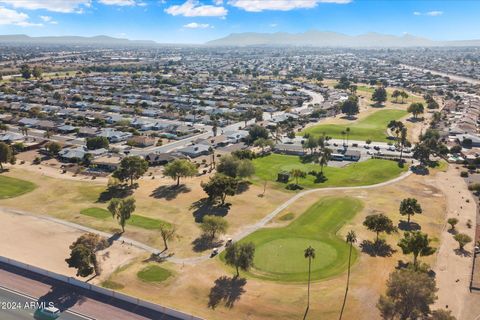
[{"x1": 0, "y1": 263, "x2": 183, "y2": 320}]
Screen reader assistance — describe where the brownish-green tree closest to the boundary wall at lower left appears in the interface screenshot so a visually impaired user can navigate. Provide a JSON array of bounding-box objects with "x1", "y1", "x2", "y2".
[{"x1": 65, "y1": 233, "x2": 108, "y2": 277}]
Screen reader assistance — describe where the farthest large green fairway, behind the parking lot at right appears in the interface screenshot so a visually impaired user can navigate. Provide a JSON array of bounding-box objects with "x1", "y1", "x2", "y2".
[{"x1": 299, "y1": 110, "x2": 407, "y2": 142}]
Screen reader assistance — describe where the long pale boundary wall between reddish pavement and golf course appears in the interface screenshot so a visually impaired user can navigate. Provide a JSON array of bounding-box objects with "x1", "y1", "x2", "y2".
[{"x1": 0, "y1": 256, "x2": 203, "y2": 320}]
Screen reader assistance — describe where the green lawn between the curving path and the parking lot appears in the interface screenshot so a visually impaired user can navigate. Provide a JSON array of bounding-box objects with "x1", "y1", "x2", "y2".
[{"x1": 253, "y1": 154, "x2": 407, "y2": 188}]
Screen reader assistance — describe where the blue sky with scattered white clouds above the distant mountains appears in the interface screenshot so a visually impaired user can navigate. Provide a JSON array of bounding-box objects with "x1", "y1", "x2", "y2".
[{"x1": 0, "y1": 0, "x2": 480, "y2": 43}]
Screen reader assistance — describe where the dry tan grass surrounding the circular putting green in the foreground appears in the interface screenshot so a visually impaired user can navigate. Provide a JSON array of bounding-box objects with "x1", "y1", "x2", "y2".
[{"x1": 103, "y1": 170, "x2": 445, "y2": 320}]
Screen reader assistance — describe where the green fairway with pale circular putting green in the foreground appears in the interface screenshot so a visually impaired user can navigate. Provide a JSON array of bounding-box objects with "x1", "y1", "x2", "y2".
[{"x1": 234, "y1": 197, "x2": 363, "y2": 282}]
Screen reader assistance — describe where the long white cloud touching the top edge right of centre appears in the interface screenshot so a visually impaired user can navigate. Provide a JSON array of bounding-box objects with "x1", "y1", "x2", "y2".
[{"x1": 228, "y1": 0, "x2": 352, "y2": 12}]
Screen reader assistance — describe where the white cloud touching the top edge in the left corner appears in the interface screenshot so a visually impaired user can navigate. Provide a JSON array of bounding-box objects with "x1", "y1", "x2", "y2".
[{"x1": 0, "y1": 0, "x2": 91, "y2": 13}]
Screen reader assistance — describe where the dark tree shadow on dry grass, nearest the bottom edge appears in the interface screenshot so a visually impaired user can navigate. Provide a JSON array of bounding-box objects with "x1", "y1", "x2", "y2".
[{"x1": 208, "y1": 276, "x2": 247, "y2": 309}]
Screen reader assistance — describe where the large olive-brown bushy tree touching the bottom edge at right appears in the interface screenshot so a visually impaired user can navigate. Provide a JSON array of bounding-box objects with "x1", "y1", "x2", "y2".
[{"x1": 377, "y1": 269, "x2": 438, "y2": 320}]
